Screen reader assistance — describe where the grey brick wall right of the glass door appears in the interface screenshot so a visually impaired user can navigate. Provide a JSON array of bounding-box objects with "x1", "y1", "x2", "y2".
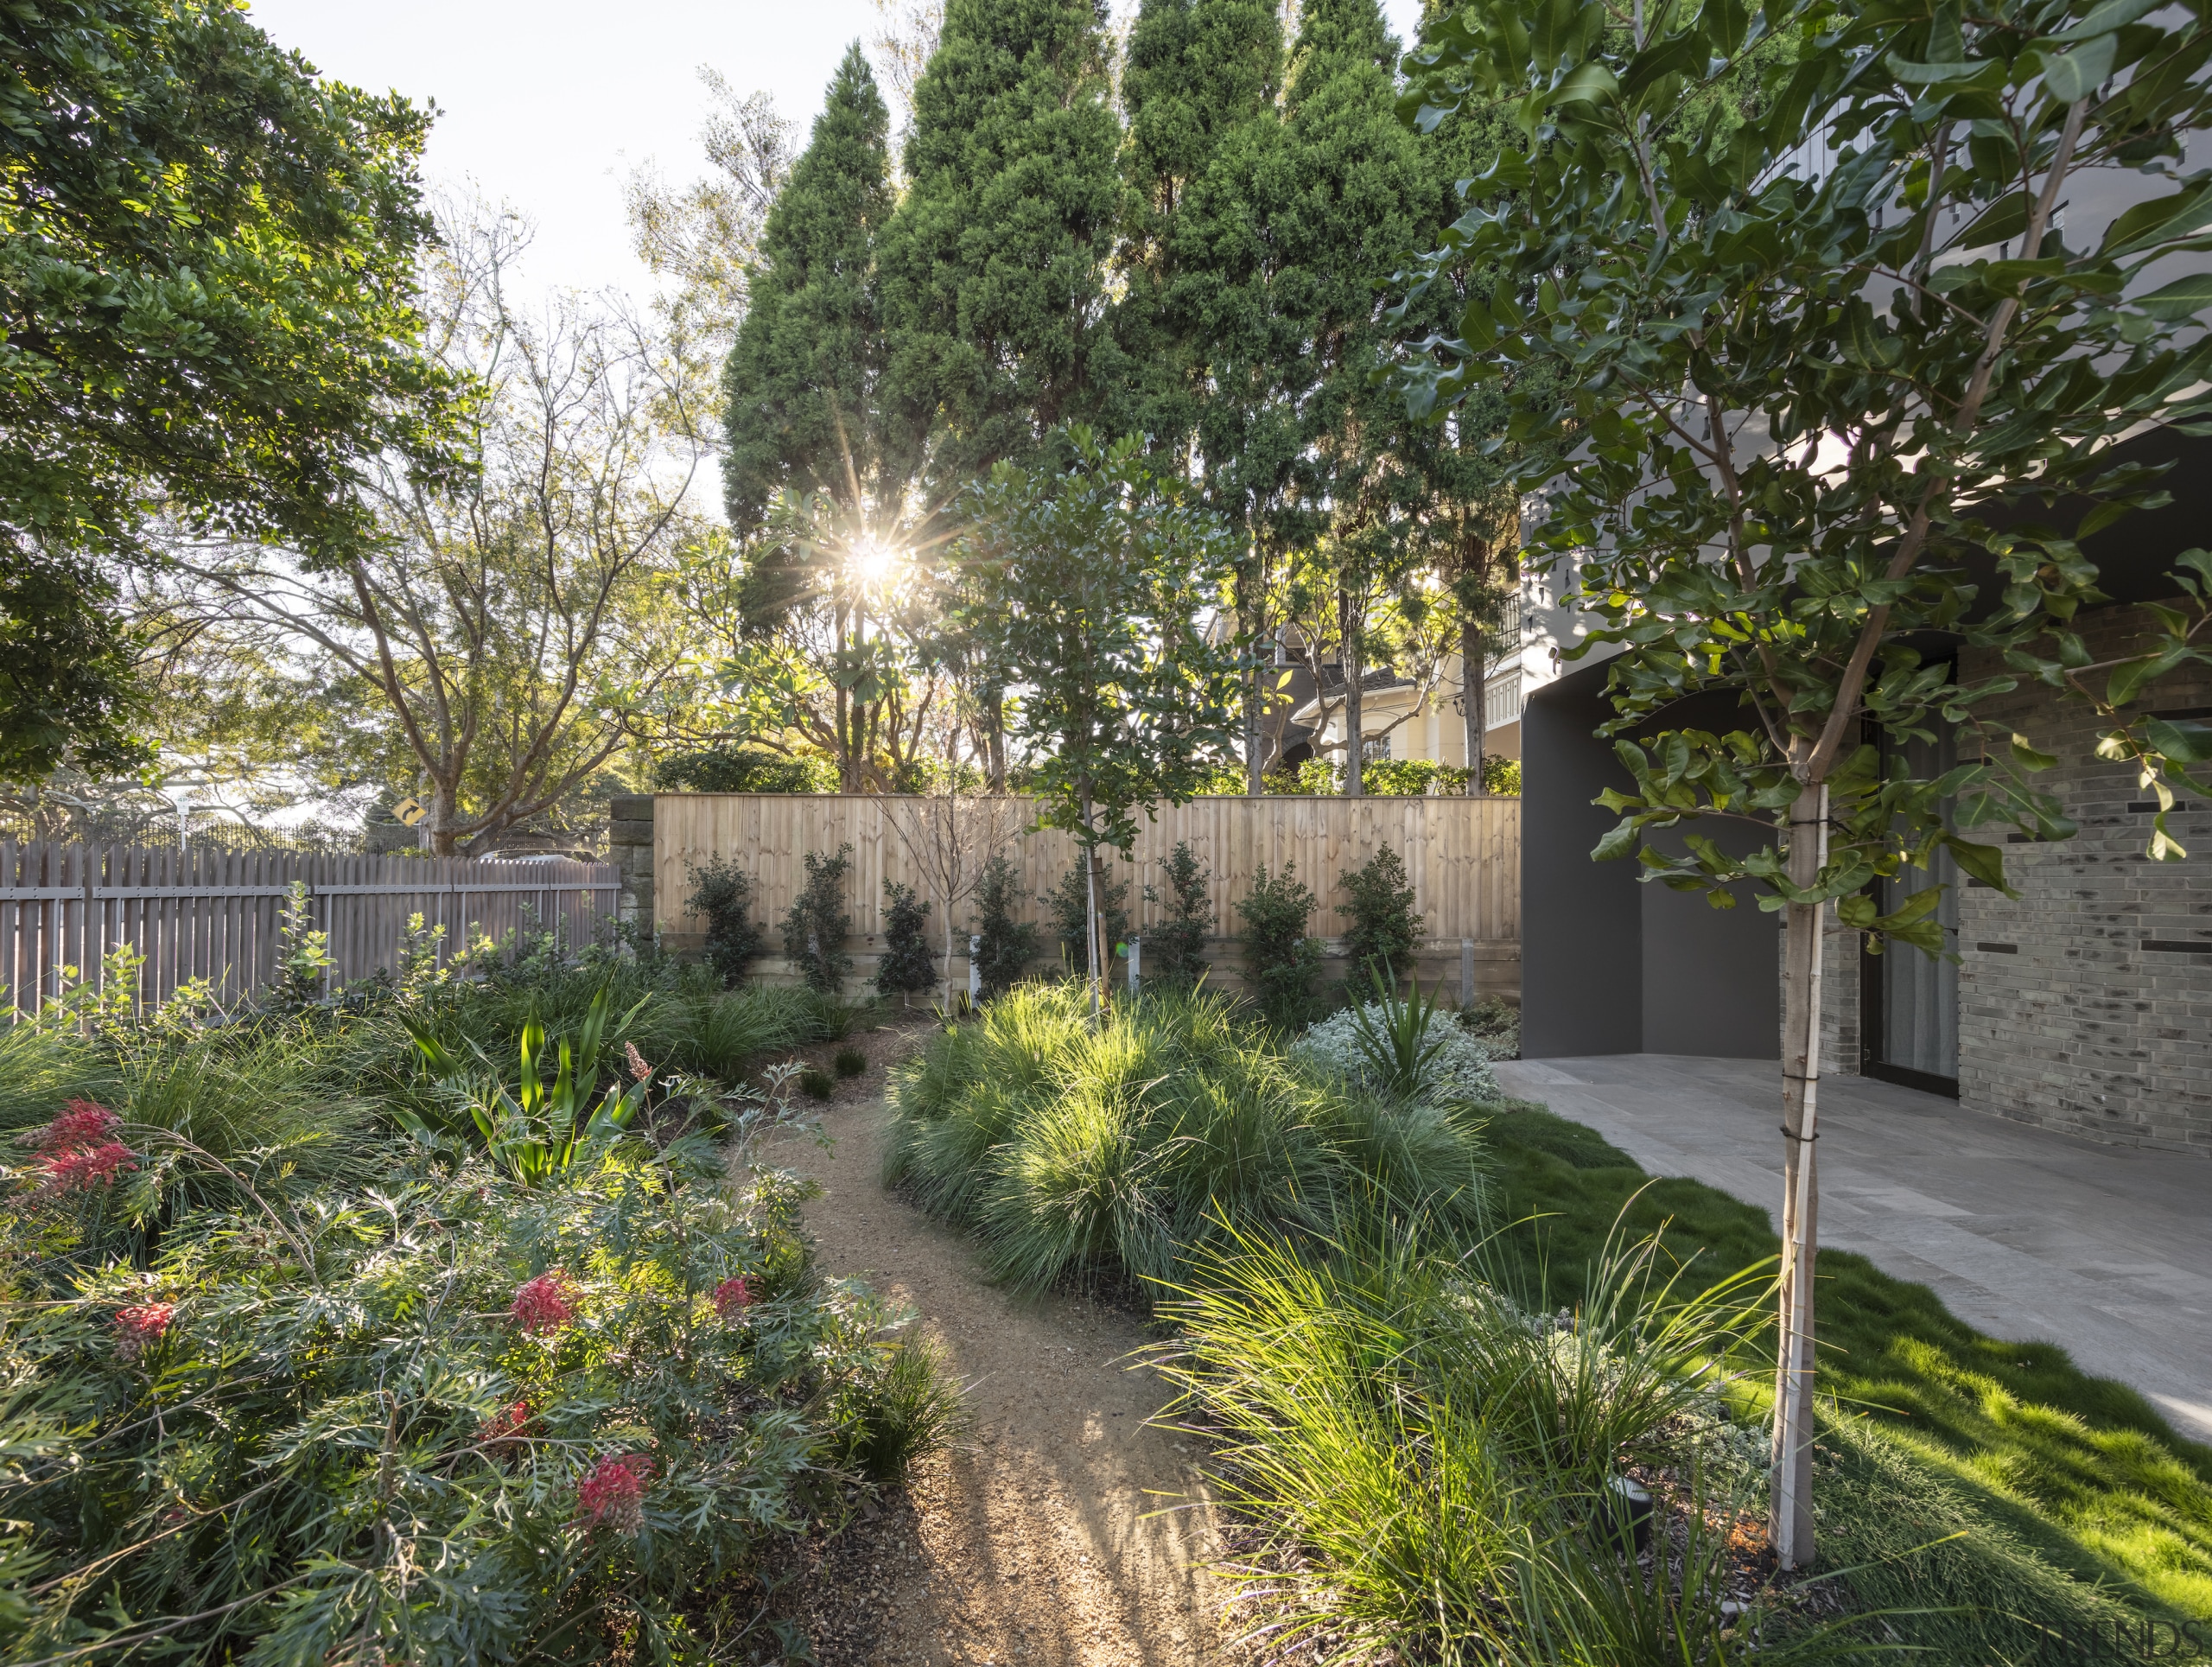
[{"x1": 1960, "y1": 608, "x2": 2212, "y2": 1156}]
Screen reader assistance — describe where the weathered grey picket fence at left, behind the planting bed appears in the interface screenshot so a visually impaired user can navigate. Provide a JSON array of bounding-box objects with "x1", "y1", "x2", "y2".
[{"x1": 0, "y1": 840, "x2": 617, "y2": 1017}]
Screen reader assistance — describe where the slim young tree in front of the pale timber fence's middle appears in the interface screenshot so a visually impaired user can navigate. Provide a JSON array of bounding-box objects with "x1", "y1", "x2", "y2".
[{"x1": 956, "y1": 427, "x2": 1243, "y2": 1013}]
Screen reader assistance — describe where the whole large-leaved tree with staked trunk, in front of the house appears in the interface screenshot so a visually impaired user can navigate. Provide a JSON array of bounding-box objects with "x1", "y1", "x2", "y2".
[{"x1": 1405, "y1": 0, "x2": 2212, "y2": 1568}]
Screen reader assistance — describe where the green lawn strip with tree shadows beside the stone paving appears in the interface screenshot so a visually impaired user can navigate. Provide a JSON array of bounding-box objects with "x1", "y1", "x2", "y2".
[{"x1": 1486, "y1": 1108, "x2": 2212, "y2": 1663}]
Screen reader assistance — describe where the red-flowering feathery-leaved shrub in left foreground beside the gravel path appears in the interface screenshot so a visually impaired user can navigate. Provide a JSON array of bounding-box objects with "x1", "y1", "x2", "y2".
[{"x1": 0, "y1": 1108, "x2": 951, "y2": 1667}]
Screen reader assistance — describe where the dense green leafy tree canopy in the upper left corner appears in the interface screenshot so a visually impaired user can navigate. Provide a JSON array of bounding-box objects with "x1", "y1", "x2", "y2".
[{"x1": 0, "y1": 0, "x2": 455, "y2": 779}]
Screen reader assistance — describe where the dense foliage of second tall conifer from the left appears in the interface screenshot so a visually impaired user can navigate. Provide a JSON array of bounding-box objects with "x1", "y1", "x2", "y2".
[{"x1": 880, "y1": 0, "x2": 1122, "y2": 486}]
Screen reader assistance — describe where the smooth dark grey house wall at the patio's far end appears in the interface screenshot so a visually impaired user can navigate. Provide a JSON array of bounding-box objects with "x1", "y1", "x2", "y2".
[{"x1": 1522, "y1": 665, "x2": 1781, "y2": 1059}]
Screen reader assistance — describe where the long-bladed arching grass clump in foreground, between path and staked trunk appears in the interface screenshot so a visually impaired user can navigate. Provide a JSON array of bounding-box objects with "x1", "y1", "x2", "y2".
[{"x1": 1159, "y1": 1227, "x2": 1845, "y2": 1667}]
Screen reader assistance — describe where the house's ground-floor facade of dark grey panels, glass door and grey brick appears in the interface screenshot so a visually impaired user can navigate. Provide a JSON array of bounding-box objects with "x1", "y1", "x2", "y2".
[{"x1": 1522, "y1": 433, "x2": 2212, "y2": 1156}]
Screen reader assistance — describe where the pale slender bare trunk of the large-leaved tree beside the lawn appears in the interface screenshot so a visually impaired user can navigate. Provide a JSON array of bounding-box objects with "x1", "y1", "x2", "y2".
[{"x1": 1767, "y1": 783, "x2": 1827, "y2": 1569}]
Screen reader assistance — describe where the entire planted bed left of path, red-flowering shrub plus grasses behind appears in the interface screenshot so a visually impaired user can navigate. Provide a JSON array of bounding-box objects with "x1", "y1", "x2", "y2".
[{"x1": 0, "y1": 928, "x2": 956, "y2": 1663}]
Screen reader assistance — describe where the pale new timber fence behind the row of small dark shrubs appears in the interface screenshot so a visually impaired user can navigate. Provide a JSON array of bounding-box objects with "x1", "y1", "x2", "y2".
[{"x1": 645, "y1": 793, "x2": 1520, "y2": 1002}]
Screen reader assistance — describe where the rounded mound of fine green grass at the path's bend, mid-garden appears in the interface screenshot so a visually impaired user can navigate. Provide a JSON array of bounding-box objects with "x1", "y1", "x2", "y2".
[{"x1": 885, "y1": 983, "x2": 1482, "y2": 1291}]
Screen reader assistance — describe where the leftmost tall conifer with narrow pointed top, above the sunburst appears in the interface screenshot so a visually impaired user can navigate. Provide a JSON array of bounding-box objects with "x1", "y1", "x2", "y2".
[{"x1": 723, "y1": 42, "x2": 912, "y2": 538}]
